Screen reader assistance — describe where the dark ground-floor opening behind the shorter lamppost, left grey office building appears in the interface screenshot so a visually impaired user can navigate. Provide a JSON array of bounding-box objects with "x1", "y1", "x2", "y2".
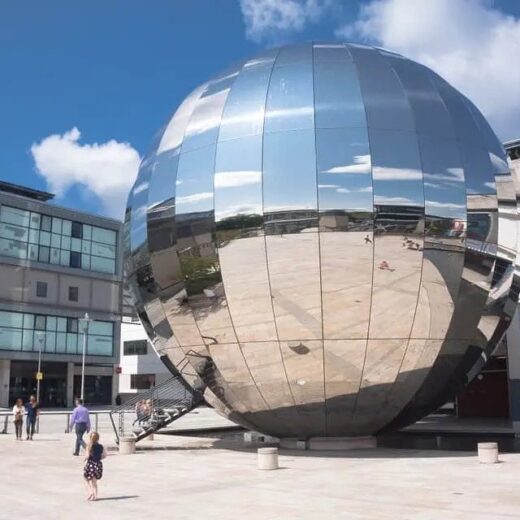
[{"x1": 9, "y1": 361, "x2": 67, "y2": 408}]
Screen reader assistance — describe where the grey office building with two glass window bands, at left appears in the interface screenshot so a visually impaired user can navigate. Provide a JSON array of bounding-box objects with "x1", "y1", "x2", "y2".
[{"x1": 0, "y1": 182, "x2": 122, "y2": 407}]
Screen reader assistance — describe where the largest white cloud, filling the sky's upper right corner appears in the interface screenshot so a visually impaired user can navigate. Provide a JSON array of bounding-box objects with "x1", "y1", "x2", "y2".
[{"x1": 337, "y1": 0, "x2": 520, "y2": 140}]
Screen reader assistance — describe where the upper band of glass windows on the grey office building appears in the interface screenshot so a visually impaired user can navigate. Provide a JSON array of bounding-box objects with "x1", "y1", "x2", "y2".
[{"x1": 0, "y1": 205, "x2": 117, "y2": 274}]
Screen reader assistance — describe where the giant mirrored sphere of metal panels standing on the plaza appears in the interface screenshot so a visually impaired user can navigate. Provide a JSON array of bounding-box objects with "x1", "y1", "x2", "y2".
[{"x1": 125, "y1": 43, "x2": 518, "y2": 437}]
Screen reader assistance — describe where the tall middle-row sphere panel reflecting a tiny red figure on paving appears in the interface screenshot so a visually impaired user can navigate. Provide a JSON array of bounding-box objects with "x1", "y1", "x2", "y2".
[{"x1": 369, "y1": 129, "x2": 424, "y2": 338}]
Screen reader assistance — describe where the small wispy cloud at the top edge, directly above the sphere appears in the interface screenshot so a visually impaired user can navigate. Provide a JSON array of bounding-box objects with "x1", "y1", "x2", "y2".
[{"x1": 240, "y1": 0, "x2": 332, "y2": 42}]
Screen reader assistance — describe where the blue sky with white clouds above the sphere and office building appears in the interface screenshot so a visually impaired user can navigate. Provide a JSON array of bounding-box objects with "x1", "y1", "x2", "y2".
[{"x1": 0, "y1": 0, "x2": 520, "y2": 219}]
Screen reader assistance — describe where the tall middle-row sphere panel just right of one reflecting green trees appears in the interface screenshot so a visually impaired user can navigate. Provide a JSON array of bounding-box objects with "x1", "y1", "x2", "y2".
[{"x1": 214, "y1": 136, "x2": 277, "y2": 341}]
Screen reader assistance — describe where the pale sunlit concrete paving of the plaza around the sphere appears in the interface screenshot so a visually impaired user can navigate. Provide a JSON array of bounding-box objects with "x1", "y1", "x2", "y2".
[{"x1": 0, "y1": 432, "x2": 520, "y2": 520}]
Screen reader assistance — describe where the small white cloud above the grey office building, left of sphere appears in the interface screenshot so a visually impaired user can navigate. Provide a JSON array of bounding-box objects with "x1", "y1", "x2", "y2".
[{"x1": 31, "y1": 127, "x2": 140, "y2": 219}]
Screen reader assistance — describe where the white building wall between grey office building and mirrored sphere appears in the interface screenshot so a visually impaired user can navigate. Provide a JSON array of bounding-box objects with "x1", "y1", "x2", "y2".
[{"x1": 119, "y1": 319, "x2": 171, "y2": 397}]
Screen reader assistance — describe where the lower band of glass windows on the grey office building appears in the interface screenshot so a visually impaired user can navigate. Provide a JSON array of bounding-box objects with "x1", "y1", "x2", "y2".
[{"x1": 0, "y1": 311, "x2": 114, "y2": 356}]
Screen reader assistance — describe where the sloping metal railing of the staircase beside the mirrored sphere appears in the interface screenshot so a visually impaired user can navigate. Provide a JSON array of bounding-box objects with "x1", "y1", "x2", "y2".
[{"x1": 110, "y1": 375, "x2": 203, "y2": 444}]
